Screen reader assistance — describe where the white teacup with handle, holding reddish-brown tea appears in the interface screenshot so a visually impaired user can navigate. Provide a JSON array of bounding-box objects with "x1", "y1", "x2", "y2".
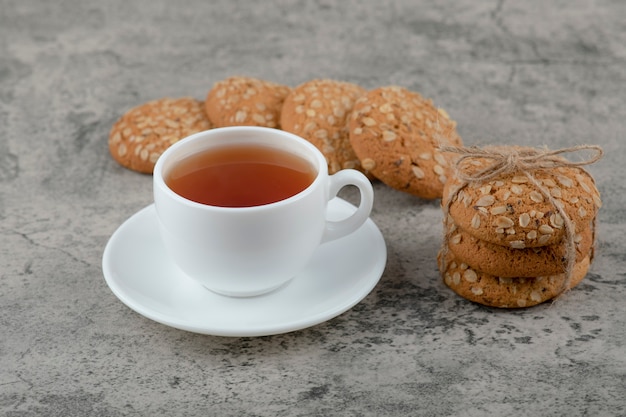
[{"x1": 154, "y1": 126, "x2": 374, "y2": 297}]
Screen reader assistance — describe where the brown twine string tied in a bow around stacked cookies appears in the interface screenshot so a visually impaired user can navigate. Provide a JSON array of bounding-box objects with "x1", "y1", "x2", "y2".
[{"x1": 439, "y1": 145, "x2": 603, "y2": 298}]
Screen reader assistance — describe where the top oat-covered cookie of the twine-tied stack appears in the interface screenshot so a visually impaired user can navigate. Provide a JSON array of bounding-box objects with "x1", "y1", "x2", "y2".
[{"x1": 442, "y1": 153, "x2": 602, "y2": 249}]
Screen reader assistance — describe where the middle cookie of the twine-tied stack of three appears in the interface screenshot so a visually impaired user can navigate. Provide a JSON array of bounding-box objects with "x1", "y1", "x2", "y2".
[{"x1": 444, "y1": 216, "x2": 594, "y2": 278}]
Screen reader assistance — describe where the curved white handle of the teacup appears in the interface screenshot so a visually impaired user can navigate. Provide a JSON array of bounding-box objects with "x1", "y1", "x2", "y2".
[{"x1": 322, "y1": 169, "x2": 374, "y2": 243}]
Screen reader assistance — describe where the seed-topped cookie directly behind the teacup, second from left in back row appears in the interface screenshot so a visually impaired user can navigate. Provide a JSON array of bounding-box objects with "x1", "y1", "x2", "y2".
[{"x1": 205, "y1": 76, "x2": 291, "y2": 128}]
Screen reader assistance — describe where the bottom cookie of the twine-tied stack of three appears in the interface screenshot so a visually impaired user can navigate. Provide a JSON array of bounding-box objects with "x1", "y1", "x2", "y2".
[{"x1": 437, "y1": 251, "x2": 590, "y2": 308}]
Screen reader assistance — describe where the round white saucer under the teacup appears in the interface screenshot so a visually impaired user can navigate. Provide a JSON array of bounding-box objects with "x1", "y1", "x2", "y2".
[{"x1": 102, "y1": 198, "x2": 387, "y2": 336}]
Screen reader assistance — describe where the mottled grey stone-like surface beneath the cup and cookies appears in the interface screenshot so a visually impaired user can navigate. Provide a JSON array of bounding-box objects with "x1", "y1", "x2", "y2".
[{"x1": 0, "y1": 0, "x2": 626, "y2": 417}]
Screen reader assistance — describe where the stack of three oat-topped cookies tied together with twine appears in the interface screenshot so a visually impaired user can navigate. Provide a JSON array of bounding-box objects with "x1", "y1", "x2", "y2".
[{"x1": 438, "y1": 147, "x2": 601, "y2": 308}]
